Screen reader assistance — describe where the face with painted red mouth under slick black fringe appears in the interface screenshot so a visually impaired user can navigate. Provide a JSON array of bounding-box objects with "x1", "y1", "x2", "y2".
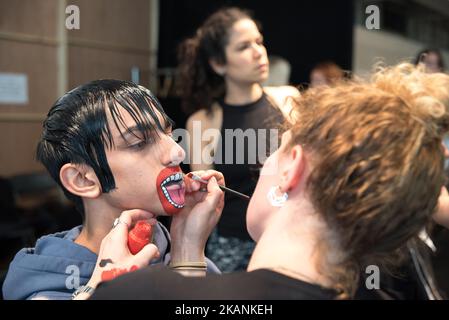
[{"x1": 104, "y1": 109, "x2": 185, "y2": 215}]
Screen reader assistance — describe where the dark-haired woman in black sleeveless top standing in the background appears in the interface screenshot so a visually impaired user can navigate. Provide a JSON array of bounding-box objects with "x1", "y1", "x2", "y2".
[{"x1": 179, "y1": 8, "x2": 299, "y2": 272}]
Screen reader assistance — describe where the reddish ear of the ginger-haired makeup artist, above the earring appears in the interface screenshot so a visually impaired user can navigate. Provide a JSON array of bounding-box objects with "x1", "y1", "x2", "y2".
[{"x1": 279, "y1": 145, "x2": 305, "y2": 192}]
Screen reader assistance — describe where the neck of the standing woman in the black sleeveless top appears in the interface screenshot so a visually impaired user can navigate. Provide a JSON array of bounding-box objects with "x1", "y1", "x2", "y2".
[{"x1": 224, "y1": 81, "x2": 263, "y2": 105}]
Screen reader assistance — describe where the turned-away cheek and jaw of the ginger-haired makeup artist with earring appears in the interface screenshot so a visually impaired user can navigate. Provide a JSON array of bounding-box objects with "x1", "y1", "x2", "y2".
[{"x1": 246, "y1": 131, "x2": 291, "y2": 242}]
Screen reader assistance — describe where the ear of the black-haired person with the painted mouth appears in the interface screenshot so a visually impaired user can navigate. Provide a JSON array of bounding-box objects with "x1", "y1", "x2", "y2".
[{"x1": 59, "y1": 163, "x2": 101, "y2": 199}]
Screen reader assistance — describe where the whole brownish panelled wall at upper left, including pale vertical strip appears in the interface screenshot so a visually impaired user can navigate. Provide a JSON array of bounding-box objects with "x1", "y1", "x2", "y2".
[{"x1": 0, "y1": 0, "x2": 151, "y2": 176}]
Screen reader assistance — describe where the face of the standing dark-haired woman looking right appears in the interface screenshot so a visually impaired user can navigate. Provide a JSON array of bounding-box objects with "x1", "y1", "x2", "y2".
[{"x1": 225, "y1": 19, "x2": 268, "y2": 84}]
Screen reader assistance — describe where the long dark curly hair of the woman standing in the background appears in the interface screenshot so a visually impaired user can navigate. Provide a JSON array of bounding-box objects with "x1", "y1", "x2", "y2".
[{"x1": 178, "y1": 7, "x2": 260, "y2": 113}]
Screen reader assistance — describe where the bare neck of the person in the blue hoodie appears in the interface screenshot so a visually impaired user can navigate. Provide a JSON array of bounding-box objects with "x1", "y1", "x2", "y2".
[{"x1": 75, "y1": 203, "x2": 121, "y2": 254}]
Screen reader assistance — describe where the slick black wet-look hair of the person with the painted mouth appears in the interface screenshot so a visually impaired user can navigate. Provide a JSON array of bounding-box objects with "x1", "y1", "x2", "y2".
[{"x1": 36, "y1": 80, "x2": 172, "y2": 215}]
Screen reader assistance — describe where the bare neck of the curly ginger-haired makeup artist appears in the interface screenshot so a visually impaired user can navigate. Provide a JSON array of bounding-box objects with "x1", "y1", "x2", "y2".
[{"x1": 248, "y1": 204, "x2": 330, "y2": 287}]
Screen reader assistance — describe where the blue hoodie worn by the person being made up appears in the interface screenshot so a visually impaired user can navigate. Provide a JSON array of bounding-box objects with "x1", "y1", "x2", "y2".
[{"x1": 3, "y1": 223, "x2": 220, "y2": 300}]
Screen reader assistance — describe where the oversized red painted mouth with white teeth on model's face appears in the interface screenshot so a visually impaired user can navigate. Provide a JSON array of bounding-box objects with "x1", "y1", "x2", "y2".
[{"x1": 157, "y1": 167, "x2": 185, "y2": 214}]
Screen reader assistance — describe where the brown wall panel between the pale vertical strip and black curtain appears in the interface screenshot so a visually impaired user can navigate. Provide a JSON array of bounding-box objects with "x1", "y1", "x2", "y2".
[{"x1": 68, "y1": 0, "x2": 150, "y2": 88}]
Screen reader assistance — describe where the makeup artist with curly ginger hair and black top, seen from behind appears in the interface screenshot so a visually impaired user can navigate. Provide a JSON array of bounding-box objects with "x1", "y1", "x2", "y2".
[{"x1": 86, "y1": 63, "x2": 449, "y2": 300}]
